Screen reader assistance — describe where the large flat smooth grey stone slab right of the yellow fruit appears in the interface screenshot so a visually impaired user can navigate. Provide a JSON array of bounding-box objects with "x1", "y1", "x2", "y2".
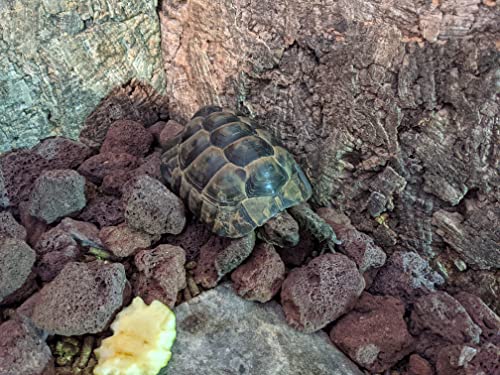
[{"x1": 161, "y1": 285, "x2": 362, "y2": 375}]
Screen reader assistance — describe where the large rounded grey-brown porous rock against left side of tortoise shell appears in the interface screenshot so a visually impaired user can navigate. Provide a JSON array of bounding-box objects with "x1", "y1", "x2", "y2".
[{"x1": 122, "y1": 175, "x2": 186, "y2": 234}]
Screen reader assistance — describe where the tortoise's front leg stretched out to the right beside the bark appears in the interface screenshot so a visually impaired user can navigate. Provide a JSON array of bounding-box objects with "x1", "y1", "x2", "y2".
[{"x1": 288, "y1": 203, "x2": 341, "y2": 253}]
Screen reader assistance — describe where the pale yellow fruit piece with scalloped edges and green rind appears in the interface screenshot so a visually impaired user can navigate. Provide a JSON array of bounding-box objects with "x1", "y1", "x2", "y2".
[{"x1": 94, "y1": 297, "x2": 175, "y2": 375}]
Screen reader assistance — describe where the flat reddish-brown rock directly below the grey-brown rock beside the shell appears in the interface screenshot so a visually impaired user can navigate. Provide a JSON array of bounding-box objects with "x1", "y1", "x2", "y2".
[{"x1": 99, "y1": 223, "x2": 160, "y2": 258}]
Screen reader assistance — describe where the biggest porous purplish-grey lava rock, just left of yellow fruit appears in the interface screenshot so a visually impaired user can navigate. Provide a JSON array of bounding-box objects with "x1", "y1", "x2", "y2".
[{"x1": 32, "y1": 261, "x2": 127, "y2": 336}]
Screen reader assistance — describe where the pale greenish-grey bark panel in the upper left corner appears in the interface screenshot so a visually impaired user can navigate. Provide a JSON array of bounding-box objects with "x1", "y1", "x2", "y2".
[{"x1": 0, "y1": 0, "x2": 165, "y2": 152}]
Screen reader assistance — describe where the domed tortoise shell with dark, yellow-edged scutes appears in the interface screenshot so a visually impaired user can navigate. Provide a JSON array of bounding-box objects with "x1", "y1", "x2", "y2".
[{"x1": 161, "y1": 106, "x2": 312, "y2": 238}]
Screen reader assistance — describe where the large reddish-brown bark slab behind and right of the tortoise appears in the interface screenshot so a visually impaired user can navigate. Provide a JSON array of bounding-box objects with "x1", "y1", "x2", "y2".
[{"x1": 160, "y1": 0, "x2": 500, "y2": 292}]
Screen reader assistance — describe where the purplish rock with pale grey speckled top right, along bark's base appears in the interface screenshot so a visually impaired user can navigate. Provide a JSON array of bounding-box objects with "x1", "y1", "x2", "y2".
[{"x1": 370, "y1": 251, "x2": 444, "y2": 302}]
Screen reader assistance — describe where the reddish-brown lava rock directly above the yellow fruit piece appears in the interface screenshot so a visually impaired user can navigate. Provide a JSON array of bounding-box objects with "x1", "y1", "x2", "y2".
[{"x1": 133, "y1": 245, "x2": 186, "y2": 308}]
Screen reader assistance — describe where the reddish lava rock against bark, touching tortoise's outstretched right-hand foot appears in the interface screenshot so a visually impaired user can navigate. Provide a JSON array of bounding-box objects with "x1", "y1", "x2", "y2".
[{"x1": 335, "y1": 225, "x2": 386, "y2": 273}]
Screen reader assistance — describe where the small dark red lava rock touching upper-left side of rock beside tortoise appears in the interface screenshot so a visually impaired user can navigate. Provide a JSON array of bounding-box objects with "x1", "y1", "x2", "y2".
[{"x1": 78, "y1": 195, "x2": 125, "y2": 228}]
